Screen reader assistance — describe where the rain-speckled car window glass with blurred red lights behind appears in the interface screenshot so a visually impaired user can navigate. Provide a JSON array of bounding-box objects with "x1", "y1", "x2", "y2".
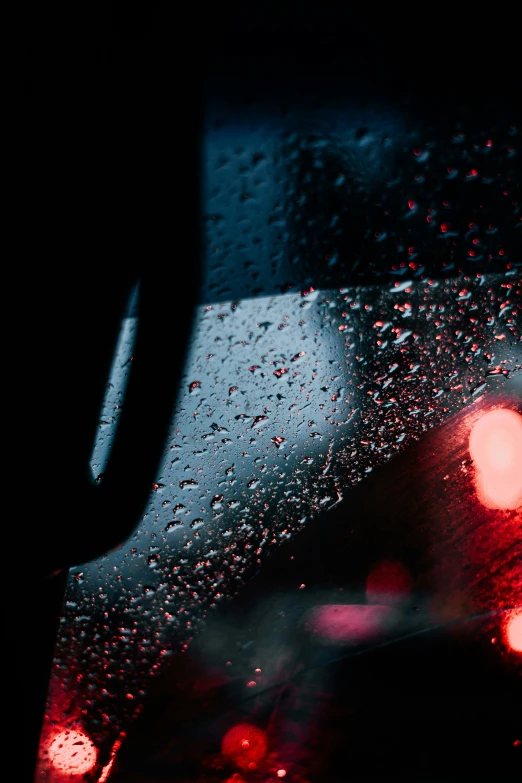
[{"x1": 37, "y1": 101, "x2": 522, "y2": 783}]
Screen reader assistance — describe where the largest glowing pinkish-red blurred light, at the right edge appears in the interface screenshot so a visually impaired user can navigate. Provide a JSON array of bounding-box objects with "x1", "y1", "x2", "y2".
[{"x1": 469, "y1": 408, "x2": 522, "y2": 509}]
